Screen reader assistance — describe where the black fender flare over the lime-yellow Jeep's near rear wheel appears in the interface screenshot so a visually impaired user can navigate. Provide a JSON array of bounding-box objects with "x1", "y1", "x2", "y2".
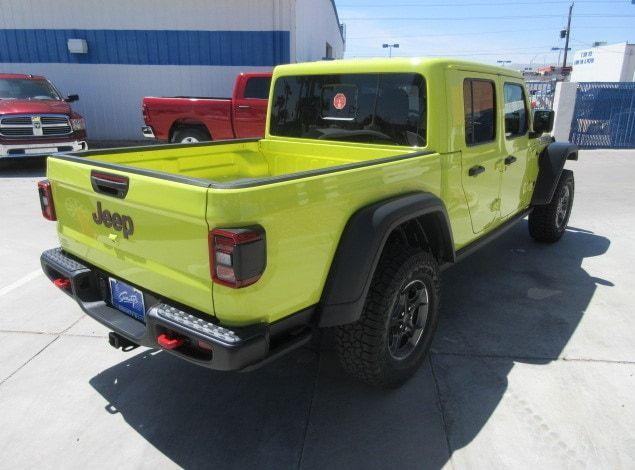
[{"x1": 318, "y1": 192, "x2": 455, "y2": 327}]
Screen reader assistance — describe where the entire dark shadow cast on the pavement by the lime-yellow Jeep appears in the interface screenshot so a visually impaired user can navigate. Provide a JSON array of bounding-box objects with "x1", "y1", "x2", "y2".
[{"x1": 90, "y1": 222, "x2": 612, "y2": 469}]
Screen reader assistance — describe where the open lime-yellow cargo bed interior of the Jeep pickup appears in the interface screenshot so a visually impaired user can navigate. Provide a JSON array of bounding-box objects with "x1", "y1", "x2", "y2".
[{"x1": 59, "y1": 139, "x2": 412, "y2": 188}]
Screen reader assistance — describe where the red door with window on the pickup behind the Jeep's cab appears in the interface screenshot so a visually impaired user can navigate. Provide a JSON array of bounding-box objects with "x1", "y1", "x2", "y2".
[{"x1": 233, "y1": 76, "x2": 271, "y2": 139}]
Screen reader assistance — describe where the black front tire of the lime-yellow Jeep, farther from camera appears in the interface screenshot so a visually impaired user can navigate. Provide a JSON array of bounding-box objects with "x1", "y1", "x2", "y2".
[{"x1": 529, "y1": 170, "x2": 575, "y2": 243}]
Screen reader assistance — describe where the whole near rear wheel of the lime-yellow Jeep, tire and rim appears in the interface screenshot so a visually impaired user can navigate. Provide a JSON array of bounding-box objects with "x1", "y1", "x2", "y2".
[{"x1": 335, "y1": 247, "x2": 439, "y2": 387}]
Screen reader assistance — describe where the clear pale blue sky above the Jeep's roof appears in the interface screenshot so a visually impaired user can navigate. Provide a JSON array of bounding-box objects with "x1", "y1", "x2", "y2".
[{"x1": 335, "y1": 0, "x2": 635, "y2": 65}]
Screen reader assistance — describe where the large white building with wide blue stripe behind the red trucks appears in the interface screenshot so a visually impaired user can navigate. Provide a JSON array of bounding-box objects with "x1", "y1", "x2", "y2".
[{"x1": 0, "y1": 0, "x2": 344, "y2": 139}]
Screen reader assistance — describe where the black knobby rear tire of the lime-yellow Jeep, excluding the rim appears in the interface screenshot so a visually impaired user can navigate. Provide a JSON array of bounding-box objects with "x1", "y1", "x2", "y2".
[{"x1": 335, "y1": 246, "x2": 439, "y2": 388}]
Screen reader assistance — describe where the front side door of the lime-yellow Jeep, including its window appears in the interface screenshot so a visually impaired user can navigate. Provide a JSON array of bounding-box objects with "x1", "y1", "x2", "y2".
[{"x1": 501, "y1": 81, "x2": 532, "y2": 217}]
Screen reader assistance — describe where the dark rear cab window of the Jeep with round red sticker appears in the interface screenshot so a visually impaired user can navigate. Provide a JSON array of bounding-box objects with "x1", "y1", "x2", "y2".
[{"x1": 269, "y1": 73, "x2": 426, "y2": 147}]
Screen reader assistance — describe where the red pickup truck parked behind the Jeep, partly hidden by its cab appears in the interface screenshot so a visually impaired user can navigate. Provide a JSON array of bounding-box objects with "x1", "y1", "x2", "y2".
[{"x1": 141, "y1": 73, "x2": 271, "y2": 143}]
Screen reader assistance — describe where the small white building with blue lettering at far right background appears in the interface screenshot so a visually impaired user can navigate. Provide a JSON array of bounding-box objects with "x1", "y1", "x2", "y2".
[{"x1": 571, "y1": 42, "x2": 635, "y2": 82}]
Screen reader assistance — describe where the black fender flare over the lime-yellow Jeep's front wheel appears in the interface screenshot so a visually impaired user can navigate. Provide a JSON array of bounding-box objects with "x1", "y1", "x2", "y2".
[{"x1": 531, "y1": 142, "x2": 578, "y2": 206}]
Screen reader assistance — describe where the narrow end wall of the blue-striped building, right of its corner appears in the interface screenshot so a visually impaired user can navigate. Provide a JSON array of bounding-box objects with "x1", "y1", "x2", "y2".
[{"x1": 295, "y1": 0, "x2": 344, "y2": 62}]
